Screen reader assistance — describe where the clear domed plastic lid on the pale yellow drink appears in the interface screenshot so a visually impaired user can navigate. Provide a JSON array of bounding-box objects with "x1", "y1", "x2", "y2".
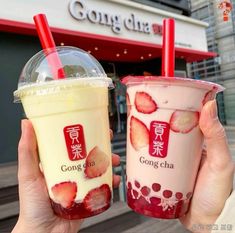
[{"x1": 14, "y1": 46, "x2": 114, "y2": 102}]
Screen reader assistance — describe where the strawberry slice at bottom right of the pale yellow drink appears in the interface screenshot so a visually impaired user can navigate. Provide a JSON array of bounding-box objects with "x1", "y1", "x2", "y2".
[{"x1": 83, "y1": 184, "x2": 111, "y2": 212}]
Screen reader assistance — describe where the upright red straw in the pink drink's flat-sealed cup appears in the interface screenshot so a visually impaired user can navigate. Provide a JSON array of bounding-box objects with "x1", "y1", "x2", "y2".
[{"x1": 162, "y1": 19, "x2": 175, "y2": 77}]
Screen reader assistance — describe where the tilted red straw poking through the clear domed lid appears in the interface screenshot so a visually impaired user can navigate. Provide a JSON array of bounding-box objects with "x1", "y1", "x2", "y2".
[{"x1": 33, "y1": 14, "x2": 65, "y2": 79}]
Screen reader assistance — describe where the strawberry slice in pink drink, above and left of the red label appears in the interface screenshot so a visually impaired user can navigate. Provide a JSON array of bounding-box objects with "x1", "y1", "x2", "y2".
[{"x1": 135, "y1": 91, "x2": 157, "y2": 114}]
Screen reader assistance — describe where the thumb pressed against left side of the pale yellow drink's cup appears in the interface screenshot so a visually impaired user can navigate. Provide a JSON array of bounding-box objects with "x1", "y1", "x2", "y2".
[{"x1": 18, "y1": 120, "x2": 41, "y2": 186}]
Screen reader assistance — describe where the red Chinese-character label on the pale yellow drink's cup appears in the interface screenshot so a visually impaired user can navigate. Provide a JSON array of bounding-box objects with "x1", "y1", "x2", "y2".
[{"x1": 64, "y1": 125, "x2": 86, "y2": 161}]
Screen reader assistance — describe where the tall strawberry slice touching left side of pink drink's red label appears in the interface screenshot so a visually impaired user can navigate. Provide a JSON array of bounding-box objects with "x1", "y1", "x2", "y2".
[{"x1": 130, "y1": 116, "x2": 149, "y2": 151}]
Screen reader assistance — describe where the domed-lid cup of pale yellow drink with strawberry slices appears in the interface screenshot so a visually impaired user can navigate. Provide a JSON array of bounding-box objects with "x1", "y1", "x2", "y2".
[{"x1": 14, "y1": 46, "x2": 113, "y2": 219}]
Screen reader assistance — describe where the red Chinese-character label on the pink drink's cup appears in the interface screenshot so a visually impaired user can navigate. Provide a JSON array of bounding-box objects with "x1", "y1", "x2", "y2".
[{"x1": 149, "y1": 121, "x2": 170, "y2": 158}]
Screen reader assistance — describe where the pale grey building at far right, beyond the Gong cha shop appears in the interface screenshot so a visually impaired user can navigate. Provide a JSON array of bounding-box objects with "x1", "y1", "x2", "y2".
[{"x1": 190, "y1": 0, "x2": 235, "y2": 125}]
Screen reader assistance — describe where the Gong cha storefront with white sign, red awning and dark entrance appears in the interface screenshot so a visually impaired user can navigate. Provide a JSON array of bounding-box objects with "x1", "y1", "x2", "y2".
[{"x1": 0, "y1": 0, "x2": 215, "y2": 163}]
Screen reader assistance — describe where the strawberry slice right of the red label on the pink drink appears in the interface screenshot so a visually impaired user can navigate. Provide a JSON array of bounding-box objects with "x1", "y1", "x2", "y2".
[{"x1": 170, "y1": 110, "x2": 199, "y2": 133}]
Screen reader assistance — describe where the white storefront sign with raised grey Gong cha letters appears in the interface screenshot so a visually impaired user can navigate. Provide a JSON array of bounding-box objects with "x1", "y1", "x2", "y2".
[{"x1": 0, "y1": 0, "x2": 207, "y2": 52}]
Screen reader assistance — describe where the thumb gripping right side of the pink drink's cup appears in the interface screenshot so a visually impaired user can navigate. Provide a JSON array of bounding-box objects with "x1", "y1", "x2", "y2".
[{"x1": 199, "y1": 100, "x2": 232, "y2": 171}]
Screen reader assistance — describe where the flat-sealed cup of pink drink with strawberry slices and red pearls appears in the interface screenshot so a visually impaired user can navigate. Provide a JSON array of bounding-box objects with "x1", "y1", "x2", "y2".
[{"x1": 122, "y1": 76, "x2": 223, "y2": 219}]
